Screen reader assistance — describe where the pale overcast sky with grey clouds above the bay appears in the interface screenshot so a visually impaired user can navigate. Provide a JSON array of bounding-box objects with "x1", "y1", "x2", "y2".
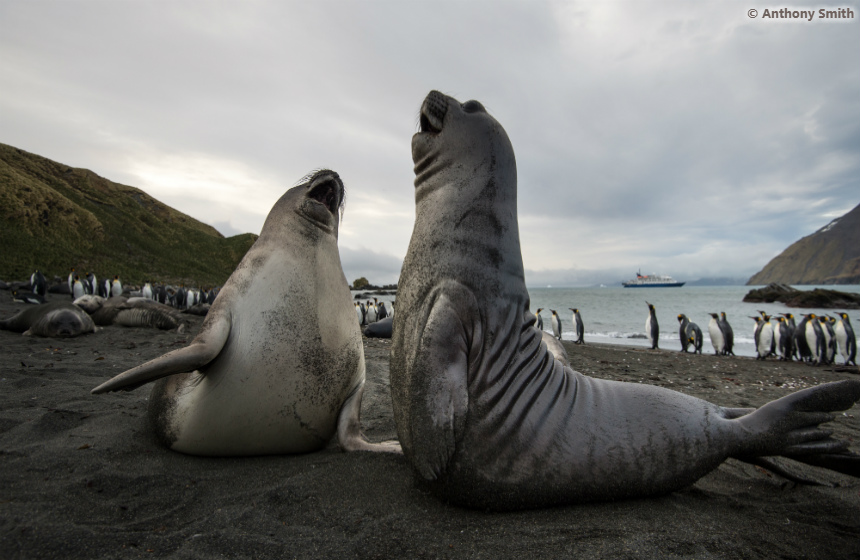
[{"x1": 0, "y1": 0, "x2": 860, "y2": 286}]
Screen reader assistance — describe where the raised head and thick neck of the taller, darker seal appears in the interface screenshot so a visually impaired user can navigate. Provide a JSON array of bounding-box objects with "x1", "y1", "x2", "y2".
[{"x1": 401, "y1": 91, "x2": 524, "y2": 292}]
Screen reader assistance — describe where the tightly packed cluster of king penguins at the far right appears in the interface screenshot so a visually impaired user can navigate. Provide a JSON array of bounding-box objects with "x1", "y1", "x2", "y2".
[{"x1": 750, "y1": 310, "x2": 857, "y2": 366}]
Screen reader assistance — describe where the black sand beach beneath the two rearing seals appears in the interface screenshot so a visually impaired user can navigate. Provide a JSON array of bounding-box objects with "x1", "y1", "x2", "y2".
[{"x1": 0, "y1": 292, "x2": 860, "y2": 559}]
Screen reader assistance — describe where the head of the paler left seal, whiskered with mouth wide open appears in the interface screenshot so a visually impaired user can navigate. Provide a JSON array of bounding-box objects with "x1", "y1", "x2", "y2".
[{"x1": 260, "y1": 169, "x2": 345, "y2": 238}]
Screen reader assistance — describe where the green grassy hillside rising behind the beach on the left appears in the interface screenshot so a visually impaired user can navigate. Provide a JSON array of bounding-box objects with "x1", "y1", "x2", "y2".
[{"x1": 0, "y1": 144, "x2": 257, "y2": 285}]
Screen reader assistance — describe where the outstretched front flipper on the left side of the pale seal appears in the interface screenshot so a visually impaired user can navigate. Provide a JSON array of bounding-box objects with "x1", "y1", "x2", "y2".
[{"x1": 92, "y1": 314, "x2": 231, "y2": 395}]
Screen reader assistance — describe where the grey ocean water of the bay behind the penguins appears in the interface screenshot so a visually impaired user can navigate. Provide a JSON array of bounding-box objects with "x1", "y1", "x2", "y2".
[{"x1": 353, "y1": 285, "x2": 860, "y2": 363}]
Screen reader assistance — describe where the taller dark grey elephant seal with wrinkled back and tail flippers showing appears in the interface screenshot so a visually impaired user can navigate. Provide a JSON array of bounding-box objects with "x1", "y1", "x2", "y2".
[{"x1": 390, "y1": 92, "x2": 860, "y2": 509}]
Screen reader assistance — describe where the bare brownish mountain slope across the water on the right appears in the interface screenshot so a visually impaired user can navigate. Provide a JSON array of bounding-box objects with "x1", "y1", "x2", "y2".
[{"x1": 747, "y1": 205, "x2": 860, "y2": 285}]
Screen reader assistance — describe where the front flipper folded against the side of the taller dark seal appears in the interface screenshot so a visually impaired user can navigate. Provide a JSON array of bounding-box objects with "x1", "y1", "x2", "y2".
[{"x1": 410, "y1": 283, "x2": 474, "y2": 480}]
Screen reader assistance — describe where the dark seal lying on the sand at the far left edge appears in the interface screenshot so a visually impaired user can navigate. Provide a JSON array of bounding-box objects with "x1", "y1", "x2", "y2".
[{"x1": 0, "y1": 301, "x2": 96, "y2": 338}]
